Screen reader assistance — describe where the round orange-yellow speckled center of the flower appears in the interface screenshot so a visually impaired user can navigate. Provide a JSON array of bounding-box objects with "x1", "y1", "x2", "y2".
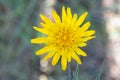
[{"x1": 54, "y1": 29, "x2": 75, "y2": 48}]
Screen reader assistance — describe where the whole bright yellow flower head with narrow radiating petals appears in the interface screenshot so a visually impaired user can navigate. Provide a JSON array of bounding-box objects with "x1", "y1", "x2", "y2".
[{"x1": 31, "y1": 6, "x2": 95, "y2": 70}]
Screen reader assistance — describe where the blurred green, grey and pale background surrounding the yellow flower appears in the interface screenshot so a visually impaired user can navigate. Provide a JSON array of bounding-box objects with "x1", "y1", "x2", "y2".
[{"x1": 0, "y1": 0, "x2": 120, "y2": 80}]
